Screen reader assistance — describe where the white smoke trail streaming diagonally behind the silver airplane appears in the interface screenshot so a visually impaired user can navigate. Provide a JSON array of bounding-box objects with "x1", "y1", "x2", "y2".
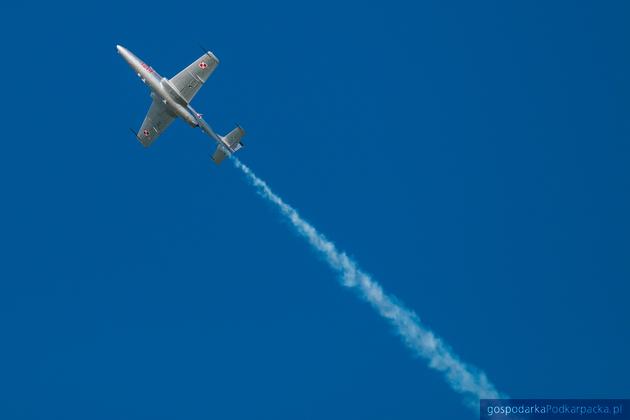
[{"x1": 232, "y1": 157, "x2": 505, "y2": 410}]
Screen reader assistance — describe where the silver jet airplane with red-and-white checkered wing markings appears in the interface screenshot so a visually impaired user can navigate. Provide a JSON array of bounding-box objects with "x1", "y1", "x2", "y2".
[{"x1": 116, "y1": 45, "x2": 245, "y2": 165}]
